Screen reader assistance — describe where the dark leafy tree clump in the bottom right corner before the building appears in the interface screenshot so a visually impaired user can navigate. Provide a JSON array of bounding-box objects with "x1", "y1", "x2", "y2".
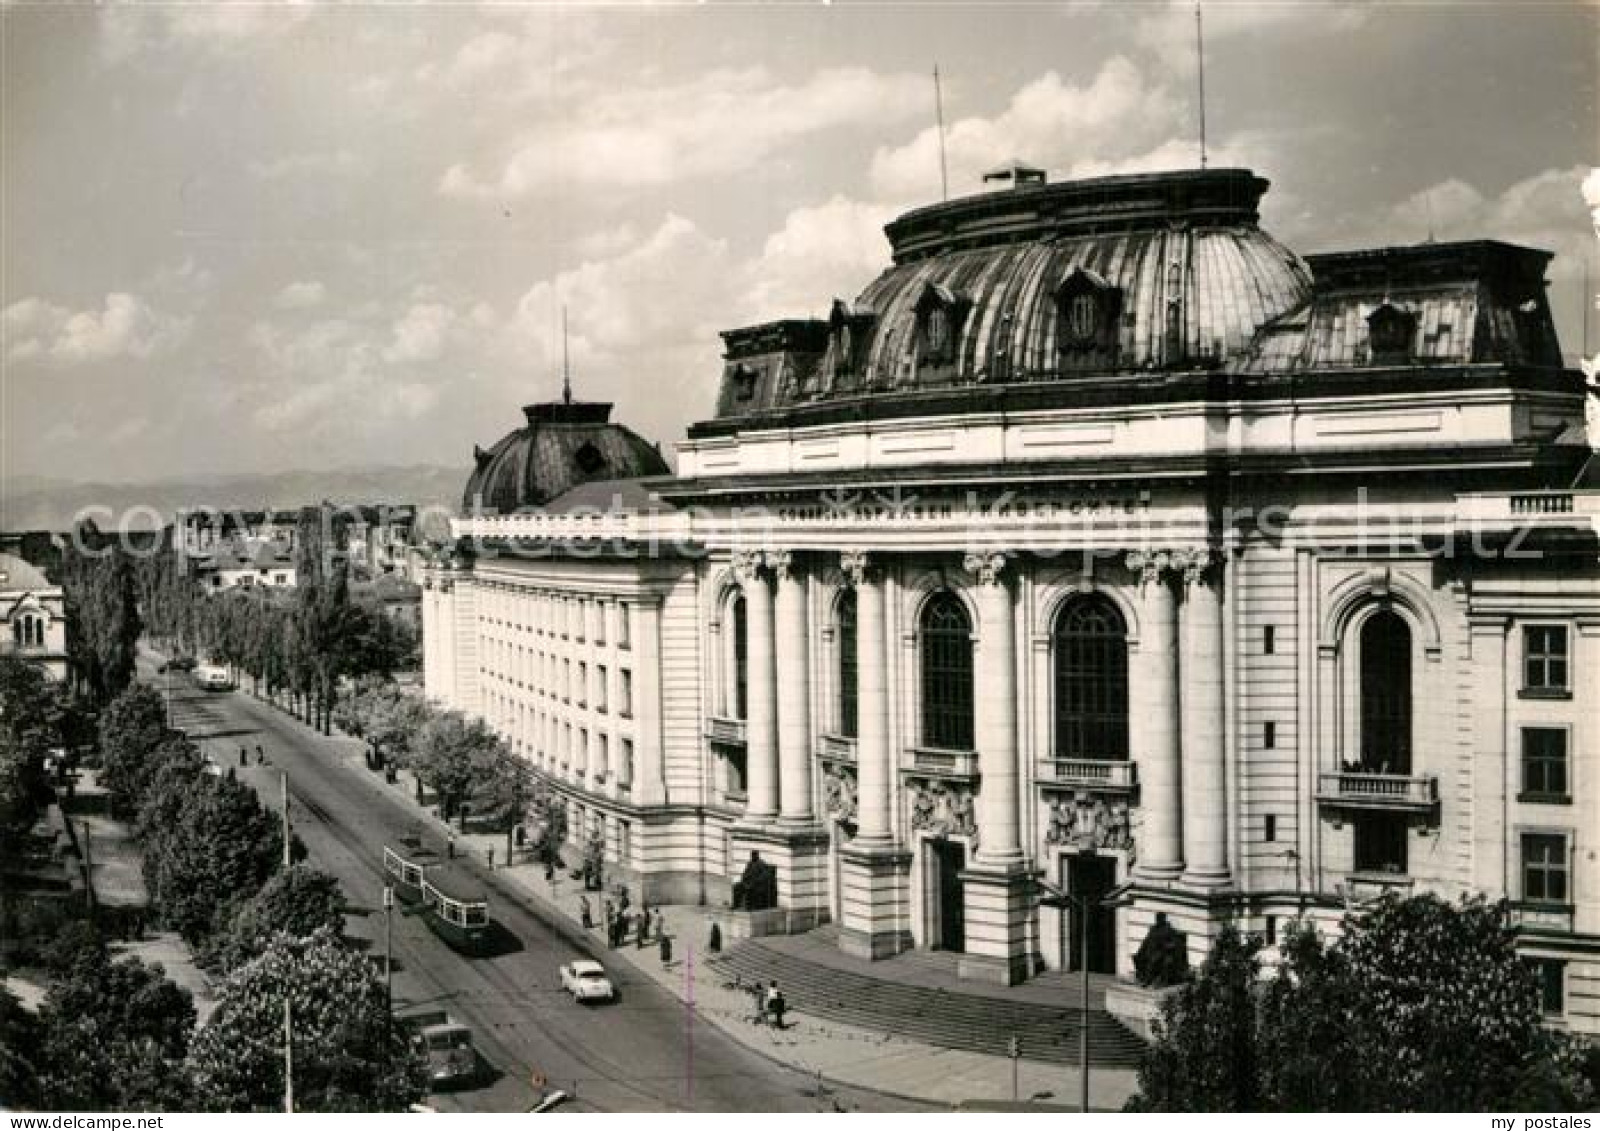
[{"x1": 1130, "y1": 896, "x2": 1595, "y2": 1112}]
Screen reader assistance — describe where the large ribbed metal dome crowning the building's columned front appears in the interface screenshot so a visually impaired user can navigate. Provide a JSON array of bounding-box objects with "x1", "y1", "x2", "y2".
[{"x1": 718, "y1": 168, "x2": 1312, "y2": 418}]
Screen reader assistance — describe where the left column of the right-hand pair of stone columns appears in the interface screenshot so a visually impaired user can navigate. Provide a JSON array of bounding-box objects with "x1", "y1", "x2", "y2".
[{"x1": 1128, "y1": 550, "x2": 1184, "y2": 880}]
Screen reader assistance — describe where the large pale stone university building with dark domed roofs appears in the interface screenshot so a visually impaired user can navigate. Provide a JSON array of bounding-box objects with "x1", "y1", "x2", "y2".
[{"x1": 422, "y1": 168, "x2": 1600, "y2": 1033}]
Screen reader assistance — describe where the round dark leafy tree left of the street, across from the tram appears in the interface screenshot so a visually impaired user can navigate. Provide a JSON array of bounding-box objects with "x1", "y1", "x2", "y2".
[{"x1": 139, "y1": 774, "x2": 283, "y2": 944}]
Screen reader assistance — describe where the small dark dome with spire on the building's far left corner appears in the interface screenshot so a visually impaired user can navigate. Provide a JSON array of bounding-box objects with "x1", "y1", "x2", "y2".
[{"x1": 461, "y1": 402, "x2": 670, "y2": 514}]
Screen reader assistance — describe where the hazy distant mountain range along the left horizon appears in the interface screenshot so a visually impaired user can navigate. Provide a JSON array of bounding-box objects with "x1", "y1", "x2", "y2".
[{"x1": 0, "y1": 464, "x2": 467, "y2": 531}]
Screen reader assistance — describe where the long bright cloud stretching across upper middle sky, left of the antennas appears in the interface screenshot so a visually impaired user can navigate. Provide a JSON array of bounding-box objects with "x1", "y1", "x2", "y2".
[{"x1": 438, "y1": 67, "x2": 926, "y2": 198}]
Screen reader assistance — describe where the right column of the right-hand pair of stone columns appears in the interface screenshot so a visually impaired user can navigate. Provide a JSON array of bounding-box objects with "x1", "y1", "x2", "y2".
[{"x1": 1181, "y1": 550, "x2": 1229, "y2": 888}]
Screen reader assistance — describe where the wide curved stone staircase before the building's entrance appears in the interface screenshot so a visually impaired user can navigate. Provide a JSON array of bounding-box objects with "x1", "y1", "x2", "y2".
[{"x1": 710, "y1": 939, "x2": 1146, "y2": 1069}]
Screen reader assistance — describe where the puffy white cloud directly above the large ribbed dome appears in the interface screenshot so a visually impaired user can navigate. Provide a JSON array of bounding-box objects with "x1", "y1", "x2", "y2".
[{"x1": 872, "y1": 56, "x2": 1181, "y2": 200}]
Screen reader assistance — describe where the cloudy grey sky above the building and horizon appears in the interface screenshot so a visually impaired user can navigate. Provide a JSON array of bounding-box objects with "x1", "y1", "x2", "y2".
[{"x1": 0, "y1": 0, "x2": 1600, "y2": 483}]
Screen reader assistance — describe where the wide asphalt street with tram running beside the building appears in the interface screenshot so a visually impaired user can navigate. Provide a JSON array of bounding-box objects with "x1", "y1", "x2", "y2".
[{"x1": 141, "y1": 657, "x2": 912, "y2": 1112}]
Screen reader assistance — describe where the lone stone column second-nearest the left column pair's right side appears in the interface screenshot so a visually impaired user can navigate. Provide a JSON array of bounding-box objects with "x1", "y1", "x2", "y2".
[{"x1": 840, "y1": 550, "x2": 894, "y2": 845}]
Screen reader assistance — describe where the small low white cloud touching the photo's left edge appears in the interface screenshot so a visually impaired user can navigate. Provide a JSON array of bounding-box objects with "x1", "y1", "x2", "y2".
[{"x1": 3, "y1": 291, "x2": 192, "y2": 365}]
